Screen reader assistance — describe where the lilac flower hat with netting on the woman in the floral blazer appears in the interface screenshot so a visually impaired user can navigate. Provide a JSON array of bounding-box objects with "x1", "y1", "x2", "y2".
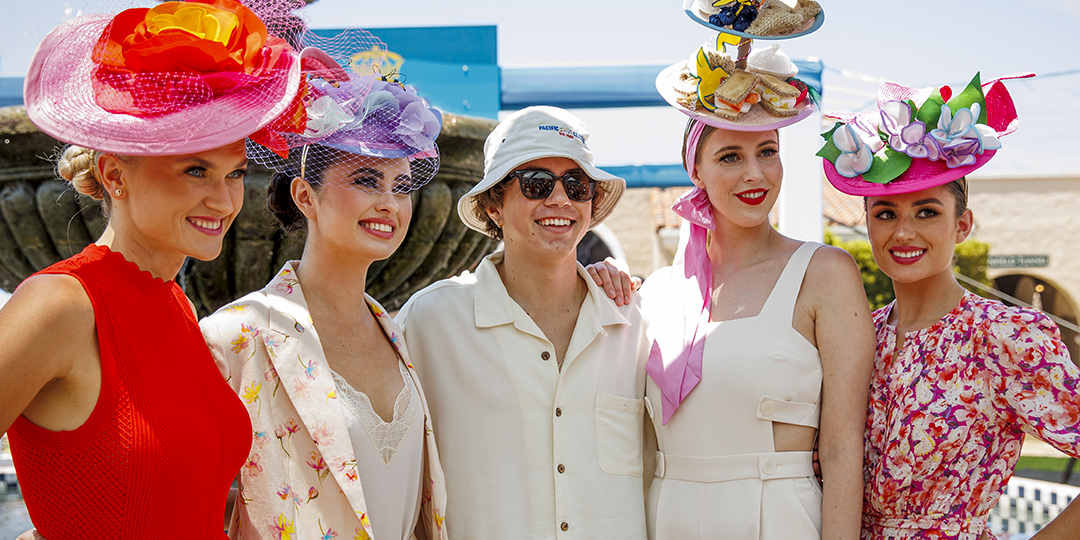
[{"x1": 248, "y1": 28, "x2": 443, "y2": 192}]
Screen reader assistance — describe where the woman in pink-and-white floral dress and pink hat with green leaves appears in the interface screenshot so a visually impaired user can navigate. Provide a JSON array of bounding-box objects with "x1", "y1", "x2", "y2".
[{"x1": 819, "y1": 76, "x2": 1080, "y2": 540}]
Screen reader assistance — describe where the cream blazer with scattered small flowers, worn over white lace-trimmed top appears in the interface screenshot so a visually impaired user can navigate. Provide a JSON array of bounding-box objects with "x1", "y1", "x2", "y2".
[{"x1": 200, "y1": 261, "x2": 447, "y2": 540}]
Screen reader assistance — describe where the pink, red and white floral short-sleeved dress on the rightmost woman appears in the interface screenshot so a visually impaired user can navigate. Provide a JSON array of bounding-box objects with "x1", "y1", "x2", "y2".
[{"x1": 862, "y1": 293, "x2": 1080, "y2": 540}]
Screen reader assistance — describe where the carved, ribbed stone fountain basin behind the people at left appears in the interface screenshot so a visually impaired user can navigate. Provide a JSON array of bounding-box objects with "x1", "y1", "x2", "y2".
[{"x1": 0, "y1": 107, "x2": 496, "y2": 316}]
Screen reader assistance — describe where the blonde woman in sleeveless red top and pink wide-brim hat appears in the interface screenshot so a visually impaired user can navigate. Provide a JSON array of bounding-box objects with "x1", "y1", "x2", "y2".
[{"x1": 0, "y1": 0, "x2": 299, "y2": 540}]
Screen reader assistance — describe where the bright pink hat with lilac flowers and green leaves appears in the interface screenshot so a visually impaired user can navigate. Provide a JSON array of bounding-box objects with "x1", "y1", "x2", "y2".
[{"x1": 818, "y1": 73, "x2": 1035, "y2": 197}]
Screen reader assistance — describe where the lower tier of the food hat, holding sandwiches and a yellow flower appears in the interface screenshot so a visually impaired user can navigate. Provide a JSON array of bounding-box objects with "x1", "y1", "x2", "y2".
[{"x1": 657, "y1": 33, "x2": 814, "y2": 132}]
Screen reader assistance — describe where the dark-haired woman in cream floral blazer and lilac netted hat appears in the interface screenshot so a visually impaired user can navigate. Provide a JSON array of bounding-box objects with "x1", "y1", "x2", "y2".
[{"x1": 200, "y1": 58, "x2": 446, "y2": 540}]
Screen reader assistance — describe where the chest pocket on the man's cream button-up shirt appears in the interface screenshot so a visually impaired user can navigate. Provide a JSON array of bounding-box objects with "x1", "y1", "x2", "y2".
[{"x1": 596, "y1": 392, "x2": 645, "y2": 476}]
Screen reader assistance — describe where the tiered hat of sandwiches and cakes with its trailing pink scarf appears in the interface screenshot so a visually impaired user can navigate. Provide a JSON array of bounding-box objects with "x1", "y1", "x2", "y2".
[{"x1": 646, "y1": 0, "x2": 825, "y2": 424}]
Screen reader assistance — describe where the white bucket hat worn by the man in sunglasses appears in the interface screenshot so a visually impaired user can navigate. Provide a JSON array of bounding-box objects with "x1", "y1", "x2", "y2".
[{"x1": 458, "y1": 107, "x2": 626, "y2": 234}]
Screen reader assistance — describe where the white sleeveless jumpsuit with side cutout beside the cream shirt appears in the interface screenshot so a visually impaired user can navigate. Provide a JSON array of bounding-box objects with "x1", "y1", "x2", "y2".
[{"x1": 646, "y1": 242, "x2": 822, "y2": 540}]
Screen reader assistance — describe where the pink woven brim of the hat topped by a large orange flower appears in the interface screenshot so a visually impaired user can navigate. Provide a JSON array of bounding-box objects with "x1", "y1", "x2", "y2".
[{"x1": 23, "y1": 14, "x2": 300, "y2": 156}]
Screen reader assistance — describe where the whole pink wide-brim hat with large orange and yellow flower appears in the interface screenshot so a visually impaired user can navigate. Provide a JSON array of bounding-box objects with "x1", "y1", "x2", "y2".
[{"x1": 24, "y1": 0, "x2": 300, "y2": 156}]
